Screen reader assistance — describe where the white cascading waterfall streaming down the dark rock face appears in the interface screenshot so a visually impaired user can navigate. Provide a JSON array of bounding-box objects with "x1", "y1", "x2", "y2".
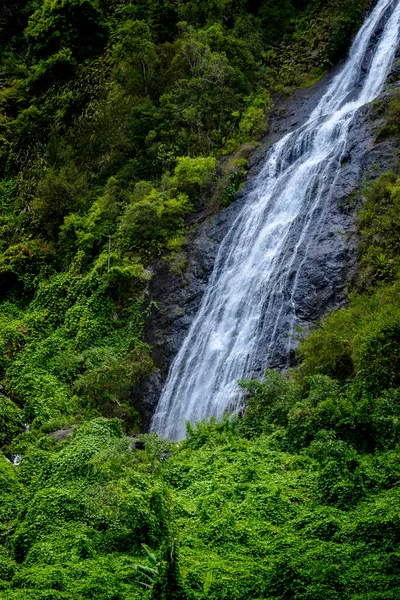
[{"x1": 151, "y1": 0, "x2": 400, "y2": 440}]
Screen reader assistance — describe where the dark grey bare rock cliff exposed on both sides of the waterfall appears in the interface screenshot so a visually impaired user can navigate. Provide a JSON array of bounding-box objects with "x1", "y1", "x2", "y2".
[{"x1": 132, "y1": 53, "x2": 400, "y2": 428}]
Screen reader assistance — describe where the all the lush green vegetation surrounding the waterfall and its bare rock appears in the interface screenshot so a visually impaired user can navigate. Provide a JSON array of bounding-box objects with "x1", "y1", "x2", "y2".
[{"x1": 0, "y1": 0, "x2": 400, "y2": 600}]
